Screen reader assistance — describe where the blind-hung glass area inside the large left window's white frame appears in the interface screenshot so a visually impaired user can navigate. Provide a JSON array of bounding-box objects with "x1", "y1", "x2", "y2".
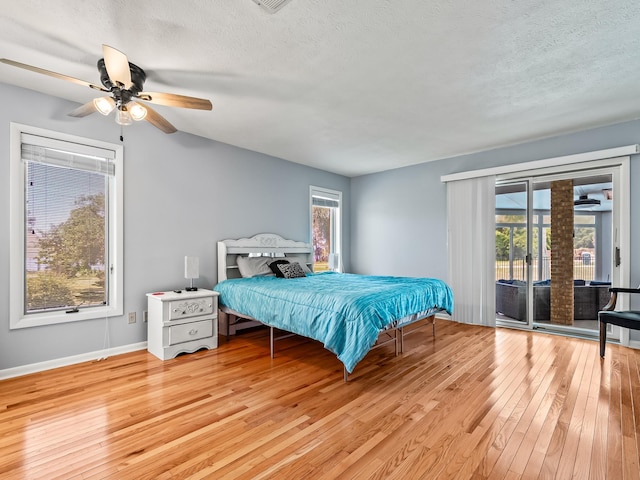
[{"x1": 20, "y1": 134, "x2": 110, "y2": 314}]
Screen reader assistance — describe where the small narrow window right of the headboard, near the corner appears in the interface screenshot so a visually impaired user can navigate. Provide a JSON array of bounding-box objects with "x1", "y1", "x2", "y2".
[{"x1": 310, "y1": 186, "x2": 342, "y2": 272}]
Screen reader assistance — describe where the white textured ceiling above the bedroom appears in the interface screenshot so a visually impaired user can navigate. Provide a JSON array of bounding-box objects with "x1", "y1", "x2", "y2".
[{"x1": 0, "y1": 0, "x2": 640, "y2": 176}]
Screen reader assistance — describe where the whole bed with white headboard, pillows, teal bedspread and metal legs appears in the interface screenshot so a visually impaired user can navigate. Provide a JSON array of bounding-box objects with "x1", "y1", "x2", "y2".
[{"x1": 214, "y1": 233, "x2": 453, "y2": 381}]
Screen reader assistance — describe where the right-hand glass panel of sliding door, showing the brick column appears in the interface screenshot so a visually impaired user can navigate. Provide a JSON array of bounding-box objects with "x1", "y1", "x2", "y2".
[{"x1": 533, "y1": 175, "x2": 612, "y2": 331}]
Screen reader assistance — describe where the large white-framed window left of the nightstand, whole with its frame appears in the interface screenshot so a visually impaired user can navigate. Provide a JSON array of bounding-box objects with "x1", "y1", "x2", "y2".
[{"x1": 10, "y1": 124, "x2": 123, "y2": 328}]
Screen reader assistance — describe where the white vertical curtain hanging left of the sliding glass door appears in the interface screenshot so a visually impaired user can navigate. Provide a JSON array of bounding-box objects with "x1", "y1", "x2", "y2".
[{"x1": 447, "y1": 176, "x2": 496, "y2": 327}]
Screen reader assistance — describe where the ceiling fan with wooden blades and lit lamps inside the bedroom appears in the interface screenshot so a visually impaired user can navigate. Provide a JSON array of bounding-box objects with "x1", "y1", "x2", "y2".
[{"x1": 0, "y1": 45, "x2": 212, "y2": 133}]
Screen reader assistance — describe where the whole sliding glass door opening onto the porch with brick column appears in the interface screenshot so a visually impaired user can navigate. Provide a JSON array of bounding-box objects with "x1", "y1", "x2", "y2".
[{"x1": 496, "y1": 167, "x2": 620, "y2": 337}]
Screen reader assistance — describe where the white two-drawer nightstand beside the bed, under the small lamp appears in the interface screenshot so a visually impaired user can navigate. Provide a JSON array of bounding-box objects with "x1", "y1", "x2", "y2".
[{"x1": 147, "y1": 288, "x2": 219, "y2": 360}]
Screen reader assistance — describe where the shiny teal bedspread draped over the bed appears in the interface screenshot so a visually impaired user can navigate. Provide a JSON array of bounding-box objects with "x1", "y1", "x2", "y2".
[{"x1": 214, "y1": 272, "x2": 453, "y2": 373}]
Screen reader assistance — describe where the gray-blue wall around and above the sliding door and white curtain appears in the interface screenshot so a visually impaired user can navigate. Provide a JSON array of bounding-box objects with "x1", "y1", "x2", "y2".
[{"x1": 351, "y1": 120, "x2": 640, "y2": 339}]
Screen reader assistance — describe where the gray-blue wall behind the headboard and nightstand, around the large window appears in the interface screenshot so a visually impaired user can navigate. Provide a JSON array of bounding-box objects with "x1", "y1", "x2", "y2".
[{"x1": 0, "y1": 80, "x2": 350, "y2": 370}]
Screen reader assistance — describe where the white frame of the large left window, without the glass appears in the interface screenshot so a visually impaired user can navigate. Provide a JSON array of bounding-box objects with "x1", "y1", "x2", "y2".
[{"x1": 9, "y1": 122, "x2": 124, "y2": 329}]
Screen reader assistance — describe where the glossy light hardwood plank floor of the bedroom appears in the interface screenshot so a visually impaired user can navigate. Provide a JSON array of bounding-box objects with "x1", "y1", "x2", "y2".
[{"x1": 0, "y1": 320, "x2": 640, "y2": 480}]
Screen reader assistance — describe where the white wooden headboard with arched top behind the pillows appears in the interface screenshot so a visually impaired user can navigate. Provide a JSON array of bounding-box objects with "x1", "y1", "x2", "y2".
[{"x1": 218, "y1": 233, "x2": 313, "y2": 282}]
